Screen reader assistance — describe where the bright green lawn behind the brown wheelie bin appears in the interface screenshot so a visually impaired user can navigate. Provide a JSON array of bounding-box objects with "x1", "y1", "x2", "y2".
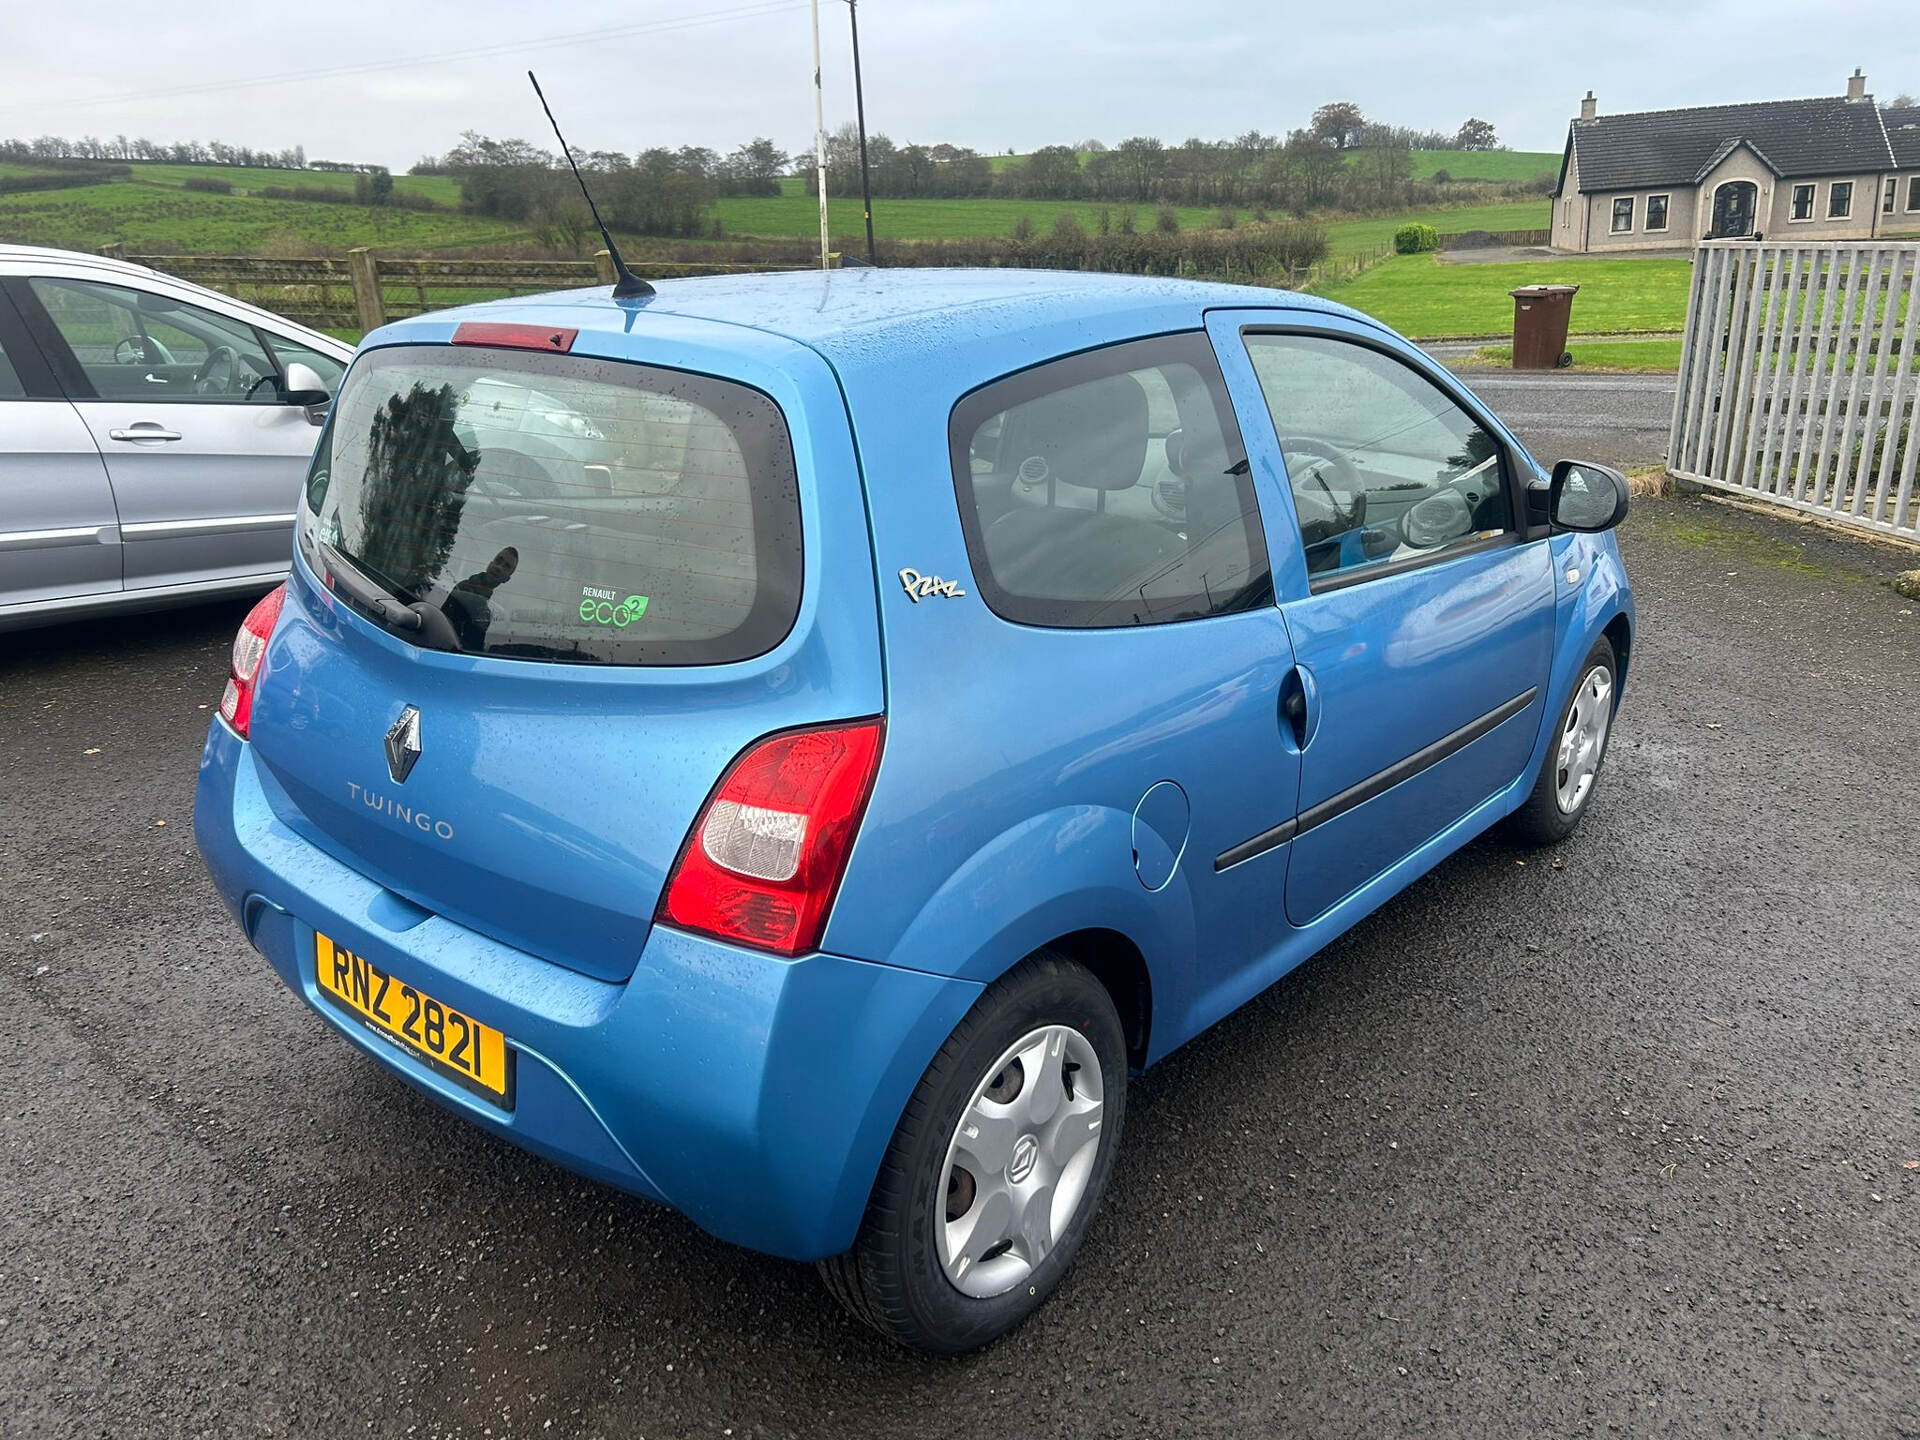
[{"x1": 1321, "y1": 255, "x2": 1693, "y2": 340}]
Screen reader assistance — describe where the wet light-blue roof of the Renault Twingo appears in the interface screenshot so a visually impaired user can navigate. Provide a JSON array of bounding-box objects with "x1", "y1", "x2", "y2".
[{"x1": 380, "y1": 267, "x2": 1377, "y2": 369}]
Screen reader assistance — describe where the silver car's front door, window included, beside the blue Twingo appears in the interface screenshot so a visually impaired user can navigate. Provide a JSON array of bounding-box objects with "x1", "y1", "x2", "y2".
[{"x1": 12, "y1": 275, "x2": 319, "y2": 589}]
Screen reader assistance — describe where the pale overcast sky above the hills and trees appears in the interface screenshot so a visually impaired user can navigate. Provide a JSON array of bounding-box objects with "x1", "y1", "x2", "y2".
[{"x1": 0, "y1": 0, "x2": 1920, "y2": 169}]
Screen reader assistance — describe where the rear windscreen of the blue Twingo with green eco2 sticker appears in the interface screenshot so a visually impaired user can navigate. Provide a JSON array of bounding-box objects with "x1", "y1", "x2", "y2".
[{"x1": 301, "y1": 346, "x2": 801, "y2": 664}]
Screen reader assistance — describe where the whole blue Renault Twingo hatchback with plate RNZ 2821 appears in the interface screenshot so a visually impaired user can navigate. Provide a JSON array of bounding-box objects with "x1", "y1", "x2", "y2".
[{"x1": 194, "y1": 271, "x2": 1634, "y2": 1352}]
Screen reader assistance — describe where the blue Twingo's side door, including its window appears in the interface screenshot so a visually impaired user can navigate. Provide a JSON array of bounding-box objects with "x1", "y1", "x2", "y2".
[{"x1": 1210, "y1": 311, "x2": 1553, "y2": 925}]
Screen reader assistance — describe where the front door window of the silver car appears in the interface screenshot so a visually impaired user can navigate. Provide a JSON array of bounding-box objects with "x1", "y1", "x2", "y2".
[{"x1": 29, "y1": 278, "x2": 280, "y2": 405}]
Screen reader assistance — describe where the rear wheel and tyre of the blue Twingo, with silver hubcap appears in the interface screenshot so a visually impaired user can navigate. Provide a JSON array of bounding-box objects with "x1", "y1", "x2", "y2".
[{"x1": 820, "y1": 950, "x2": 1127, "y2": 1356}]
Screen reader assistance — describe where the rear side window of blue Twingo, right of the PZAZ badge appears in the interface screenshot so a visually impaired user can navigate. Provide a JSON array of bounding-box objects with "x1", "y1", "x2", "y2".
[{"x1": 948, "y1": 332, "x2": 1273, "y2": 628}]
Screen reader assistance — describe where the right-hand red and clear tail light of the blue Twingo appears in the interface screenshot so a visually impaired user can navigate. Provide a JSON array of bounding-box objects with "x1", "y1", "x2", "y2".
[{"x1": 659, "y1": 720, "x2": 881, "y2": 954}]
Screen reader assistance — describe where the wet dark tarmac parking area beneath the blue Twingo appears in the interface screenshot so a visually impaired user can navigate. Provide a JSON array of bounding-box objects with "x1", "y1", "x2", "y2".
[{"x1": 0, "y1": 501, "x2": 1920, "y2": 1438}]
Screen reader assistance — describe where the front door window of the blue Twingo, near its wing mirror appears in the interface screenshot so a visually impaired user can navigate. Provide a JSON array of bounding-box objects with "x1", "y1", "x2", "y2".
[{"x1": 1246, "y1": 332, "x2": 1513, "y2": 578}]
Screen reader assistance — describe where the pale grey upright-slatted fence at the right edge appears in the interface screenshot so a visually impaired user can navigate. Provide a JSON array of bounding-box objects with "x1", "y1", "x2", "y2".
[{"x1": 1667, "y1": 240, "x2": 1920, "y2": 540}]
